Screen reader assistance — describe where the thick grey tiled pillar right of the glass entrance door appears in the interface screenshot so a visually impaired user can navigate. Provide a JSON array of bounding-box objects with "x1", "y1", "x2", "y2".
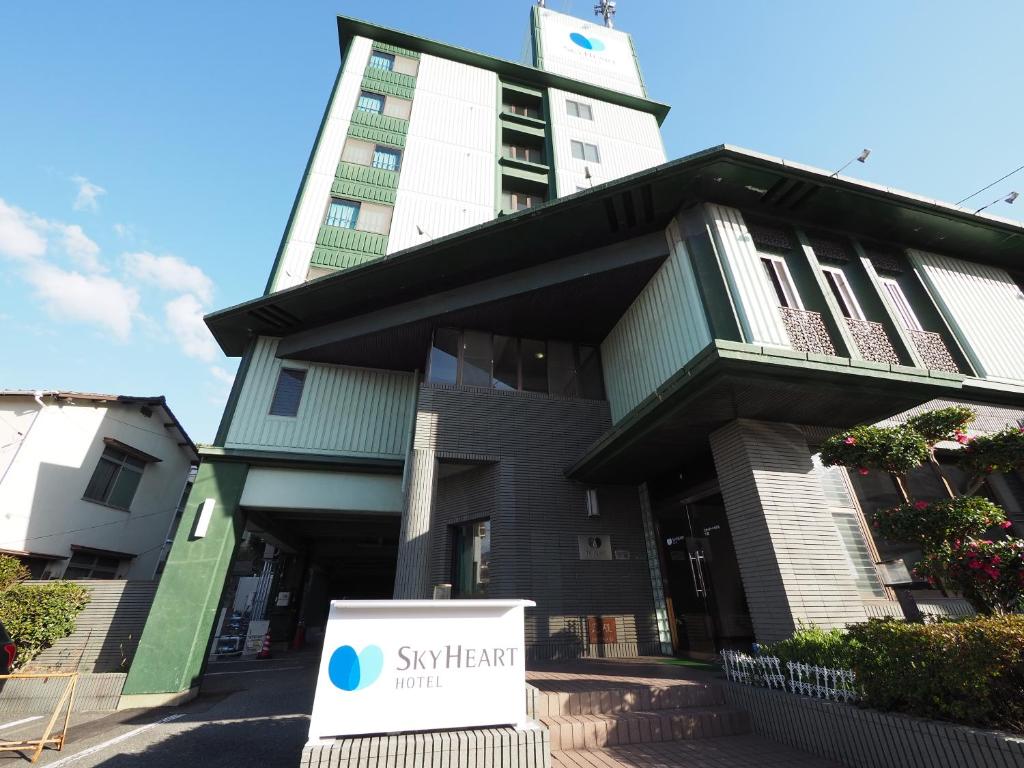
[{"x1": 711, "y1": 420, "x2": 865, "y2": 641}]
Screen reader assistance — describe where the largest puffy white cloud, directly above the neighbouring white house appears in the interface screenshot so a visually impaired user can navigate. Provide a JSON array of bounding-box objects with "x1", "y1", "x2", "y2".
[{"x1": 25, "y1": 263, "x2": 139, "y2": 341}]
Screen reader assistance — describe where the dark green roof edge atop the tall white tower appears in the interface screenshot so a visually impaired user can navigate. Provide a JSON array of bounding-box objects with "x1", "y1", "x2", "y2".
[{"x1": 338, "y1": 14, "x2": 670, "y2": 125}]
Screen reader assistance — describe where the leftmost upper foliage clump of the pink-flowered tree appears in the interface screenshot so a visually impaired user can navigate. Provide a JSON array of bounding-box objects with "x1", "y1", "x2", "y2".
[{"x1": 821, "y1": 426, "x2": 929, "y2": 474}]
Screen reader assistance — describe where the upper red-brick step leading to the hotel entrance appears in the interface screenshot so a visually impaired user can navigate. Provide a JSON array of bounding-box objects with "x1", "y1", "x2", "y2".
[{"x1": 535, "y1": 682, "x2": 725, "y2": 718}]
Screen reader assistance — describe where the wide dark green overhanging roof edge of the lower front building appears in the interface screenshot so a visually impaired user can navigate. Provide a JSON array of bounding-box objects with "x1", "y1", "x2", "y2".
[{"x1": 206, "y1": 145, "x2": 1024, "y2": 356}]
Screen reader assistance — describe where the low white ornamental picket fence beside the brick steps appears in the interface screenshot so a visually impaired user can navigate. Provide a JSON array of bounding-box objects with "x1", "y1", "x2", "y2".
[{"x1": 722, "y1": 650, "x2": 860, "y2": 702}]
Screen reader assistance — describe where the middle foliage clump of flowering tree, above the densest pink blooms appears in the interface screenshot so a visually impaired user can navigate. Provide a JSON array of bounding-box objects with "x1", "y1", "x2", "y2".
[{"x1": 871, "y1": 496, "x2": 1007, "y2": 551}]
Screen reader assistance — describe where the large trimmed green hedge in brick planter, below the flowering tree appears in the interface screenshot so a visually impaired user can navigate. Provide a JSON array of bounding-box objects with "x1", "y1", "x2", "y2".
[{"x1": 848, "y1": 615, "x2": 1024, "y2": 732}]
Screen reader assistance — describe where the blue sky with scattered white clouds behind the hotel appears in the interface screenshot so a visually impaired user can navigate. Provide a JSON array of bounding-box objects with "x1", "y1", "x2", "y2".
[{"x1": 0, "y1": 0, "x2": 1024, "y2": 441}]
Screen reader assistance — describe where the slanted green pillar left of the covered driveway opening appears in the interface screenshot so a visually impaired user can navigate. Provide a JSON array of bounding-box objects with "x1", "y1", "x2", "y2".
[{"x1": 119, "y1": 461, "x2": 249, "y2": 709}]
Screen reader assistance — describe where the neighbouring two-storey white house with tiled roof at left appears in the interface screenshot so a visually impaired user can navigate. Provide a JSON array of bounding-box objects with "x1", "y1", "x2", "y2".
[{"x1": 0, "y1": 390, "x2": 199, "y2": 580}]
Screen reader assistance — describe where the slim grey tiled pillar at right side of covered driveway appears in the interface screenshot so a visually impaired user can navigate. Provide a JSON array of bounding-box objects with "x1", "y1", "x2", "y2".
[{"x1": 394, "y1": 447, "x2": 437, "y2": 600}]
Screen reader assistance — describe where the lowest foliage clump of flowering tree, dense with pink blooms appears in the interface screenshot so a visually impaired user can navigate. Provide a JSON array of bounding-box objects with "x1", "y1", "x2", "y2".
[{"x1": 918, "y1": 539, "x2": 1024, "y2": 613}]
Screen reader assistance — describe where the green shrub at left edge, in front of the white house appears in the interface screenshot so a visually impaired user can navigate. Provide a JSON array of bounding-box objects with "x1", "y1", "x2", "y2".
[{"x1": 0, "y1": 556, "x2": 89, "y2": 669}]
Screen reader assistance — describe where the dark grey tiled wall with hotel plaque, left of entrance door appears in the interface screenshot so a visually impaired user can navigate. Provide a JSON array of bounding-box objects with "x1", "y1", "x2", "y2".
[{"x1": 398, "y1": 384, "x2": 660, "y2": 658}]
